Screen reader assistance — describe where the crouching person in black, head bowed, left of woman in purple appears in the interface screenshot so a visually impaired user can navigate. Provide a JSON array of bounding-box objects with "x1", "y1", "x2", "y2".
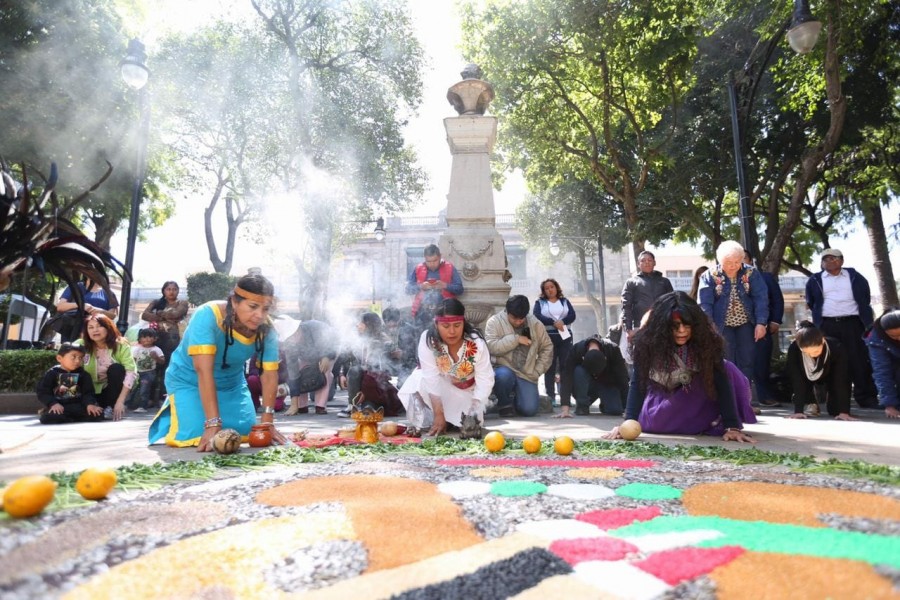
[{"x1": 556, "y1": 335, "x2": 628, "y2": 418}]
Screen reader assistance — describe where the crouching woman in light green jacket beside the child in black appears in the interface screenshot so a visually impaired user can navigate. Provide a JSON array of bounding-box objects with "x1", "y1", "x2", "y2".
[{"x1": 81, "y1": 314, "x2": 137, "y2": 421}]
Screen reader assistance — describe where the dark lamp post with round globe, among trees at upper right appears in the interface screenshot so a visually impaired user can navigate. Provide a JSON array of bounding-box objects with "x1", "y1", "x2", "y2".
[{"x1": 728, "y1": 0, "x2": 822, "y2": 258}]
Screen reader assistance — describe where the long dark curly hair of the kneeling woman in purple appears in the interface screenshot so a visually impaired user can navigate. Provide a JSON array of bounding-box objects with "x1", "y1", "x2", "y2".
[{"x1": 632, "y1": 292, "x2": 725, "y2": 398}]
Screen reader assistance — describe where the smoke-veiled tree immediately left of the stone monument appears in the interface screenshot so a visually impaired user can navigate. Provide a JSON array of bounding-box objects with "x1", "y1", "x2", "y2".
[{"x1": 251, "y1": 0, "x2": 425, "y2": 318}]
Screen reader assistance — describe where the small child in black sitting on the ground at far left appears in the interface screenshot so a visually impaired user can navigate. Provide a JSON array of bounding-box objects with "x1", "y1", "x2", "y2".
[{"x1": 35, "y1": 342, "x2": 103, "y2": 425}]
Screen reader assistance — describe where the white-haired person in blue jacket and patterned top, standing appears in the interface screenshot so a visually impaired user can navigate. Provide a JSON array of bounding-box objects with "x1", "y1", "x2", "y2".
[{"x1": 699, "y1": 241, "x2": 769, "y2": 398}]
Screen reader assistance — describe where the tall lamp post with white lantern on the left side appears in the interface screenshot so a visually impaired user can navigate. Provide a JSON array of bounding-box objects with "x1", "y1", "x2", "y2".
[{"x1": 116, "y1": 39, "x2": 150, "y2": 334}]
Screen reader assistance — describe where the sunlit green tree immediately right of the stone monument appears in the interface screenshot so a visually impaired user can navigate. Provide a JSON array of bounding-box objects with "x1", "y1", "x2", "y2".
[{"x1": 463, "y1": 0, "x2": 703, "y2": 253}]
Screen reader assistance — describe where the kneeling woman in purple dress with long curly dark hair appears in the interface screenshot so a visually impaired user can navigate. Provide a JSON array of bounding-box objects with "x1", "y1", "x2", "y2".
[{"x1": 604, "y1": 292, "x2": 756, "y2": 443}]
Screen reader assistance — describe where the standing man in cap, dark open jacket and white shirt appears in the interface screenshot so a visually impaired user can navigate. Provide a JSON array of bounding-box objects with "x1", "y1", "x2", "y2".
[{"x1": 806, "y1": 248, "x2": 878, "y2": 408}]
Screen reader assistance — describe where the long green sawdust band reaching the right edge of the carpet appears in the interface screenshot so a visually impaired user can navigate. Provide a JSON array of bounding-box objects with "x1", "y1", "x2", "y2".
[{"x1": 609, "y1": 516, "x2": 900, "y2": 569}]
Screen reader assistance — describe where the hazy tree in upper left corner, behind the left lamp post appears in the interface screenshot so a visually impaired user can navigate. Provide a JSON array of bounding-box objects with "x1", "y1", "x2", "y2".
[{"x1": 0, "y1": 0, "x2": 171, "y2": 249}]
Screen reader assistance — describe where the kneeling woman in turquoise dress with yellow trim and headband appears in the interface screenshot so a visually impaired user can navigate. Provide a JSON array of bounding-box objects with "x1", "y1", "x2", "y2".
[{"x1": 149, "y1": 275, "x2": 285, "y2": 452}]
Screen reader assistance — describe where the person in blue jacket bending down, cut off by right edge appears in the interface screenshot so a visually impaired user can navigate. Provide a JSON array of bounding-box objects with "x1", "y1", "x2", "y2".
[{"x1": 865, "y1": 306, "x2": 900, "y2": 419}]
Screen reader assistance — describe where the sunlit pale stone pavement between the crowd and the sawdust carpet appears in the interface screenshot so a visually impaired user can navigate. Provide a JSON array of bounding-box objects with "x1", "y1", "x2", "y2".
[{"x1": 0, "y1": 393, "x2": 900, "y2": 481}]
